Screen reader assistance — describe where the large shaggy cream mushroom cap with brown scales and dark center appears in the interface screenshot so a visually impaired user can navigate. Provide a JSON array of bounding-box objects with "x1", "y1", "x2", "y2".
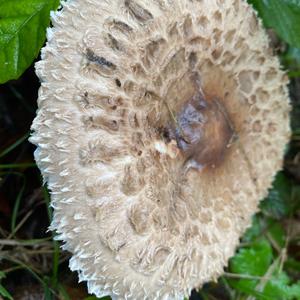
[{"x1": 31, "y1": 0, "x2": 290, "y2": 299}]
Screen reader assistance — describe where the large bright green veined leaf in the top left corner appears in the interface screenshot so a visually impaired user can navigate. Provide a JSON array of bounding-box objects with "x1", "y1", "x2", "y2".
[{"x1": 0, "y1": 0, "x2": 59, "y2": 84}]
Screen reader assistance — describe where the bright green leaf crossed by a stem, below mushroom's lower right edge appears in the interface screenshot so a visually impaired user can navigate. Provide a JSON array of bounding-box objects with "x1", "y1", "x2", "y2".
[{"x1": 229, "y1": 238, "x2": 273, "y2": 295}]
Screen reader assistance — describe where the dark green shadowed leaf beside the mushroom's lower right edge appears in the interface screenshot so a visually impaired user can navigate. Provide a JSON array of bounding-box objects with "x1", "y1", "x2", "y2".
[{"x1": 260, "y1": 172, "x2": 293, "y2": 219}]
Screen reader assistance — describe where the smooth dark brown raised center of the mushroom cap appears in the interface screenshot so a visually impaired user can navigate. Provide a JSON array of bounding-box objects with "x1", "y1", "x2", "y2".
[{"x1": 168, "y1": 92, "x2": 235, "y2": 170}]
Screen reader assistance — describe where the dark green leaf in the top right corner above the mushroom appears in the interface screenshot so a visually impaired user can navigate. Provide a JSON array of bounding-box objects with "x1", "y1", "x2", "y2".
[{"x1": 248, "y1": 0, "x2": 300, "y2": 48}]
